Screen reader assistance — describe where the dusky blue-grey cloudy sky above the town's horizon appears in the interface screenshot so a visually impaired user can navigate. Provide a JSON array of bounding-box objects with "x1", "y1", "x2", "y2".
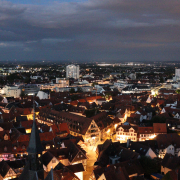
[{"x1": 0, "y1": 0, "x2": 180, "y2": 62}]
